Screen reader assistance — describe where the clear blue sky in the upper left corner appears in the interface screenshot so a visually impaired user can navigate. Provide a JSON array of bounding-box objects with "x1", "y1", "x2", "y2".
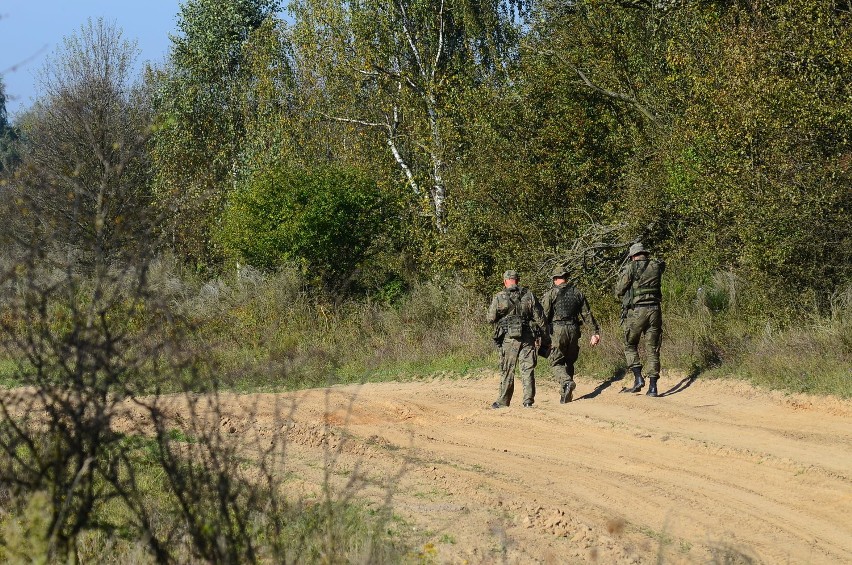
[{"x1": 0, "y1": 0, "x2": 180, "y2": 119}]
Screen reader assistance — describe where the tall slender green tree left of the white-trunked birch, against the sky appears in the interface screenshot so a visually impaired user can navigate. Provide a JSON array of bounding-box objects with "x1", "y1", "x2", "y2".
[{"x1": 149, "y1": 0, "x2": 278, "y2": 265}]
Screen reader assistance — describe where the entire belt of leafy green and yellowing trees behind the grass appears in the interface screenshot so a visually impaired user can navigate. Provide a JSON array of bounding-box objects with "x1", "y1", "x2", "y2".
[{"x1": 2, "y1": 0, "x2": 852, "y2": 308}]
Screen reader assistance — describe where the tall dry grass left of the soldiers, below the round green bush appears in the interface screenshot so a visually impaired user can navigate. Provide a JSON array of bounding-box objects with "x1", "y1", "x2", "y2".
[{"x1": 155, "y1": 258, "x2": 493, "y2": 390}]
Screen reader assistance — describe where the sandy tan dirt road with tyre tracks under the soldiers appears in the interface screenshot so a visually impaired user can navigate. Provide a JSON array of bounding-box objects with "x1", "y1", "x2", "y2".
[{"x1": 201, "y1": 373, "x2": 852, "y2": 563}]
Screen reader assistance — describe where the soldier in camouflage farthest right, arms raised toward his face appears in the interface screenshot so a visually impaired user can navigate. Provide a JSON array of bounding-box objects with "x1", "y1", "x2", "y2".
[{"x1": 615, "y1": 243, "x2": 666, "y2": 396}]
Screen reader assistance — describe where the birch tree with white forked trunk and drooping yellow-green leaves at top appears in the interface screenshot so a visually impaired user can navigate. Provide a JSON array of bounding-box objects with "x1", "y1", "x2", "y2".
[{"x1": 291, "y1": 0, "x2": 525, "y2": 232}]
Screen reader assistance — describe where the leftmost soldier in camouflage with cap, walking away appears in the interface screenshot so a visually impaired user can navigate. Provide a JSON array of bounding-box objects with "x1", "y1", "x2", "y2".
[{"x1": 488, "y1": 270, "x2": 545, "y2": 408}]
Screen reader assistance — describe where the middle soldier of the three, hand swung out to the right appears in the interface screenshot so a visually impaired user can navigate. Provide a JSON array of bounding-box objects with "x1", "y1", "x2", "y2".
[{"x1": 541, "y1": 267, "x2": 601, "y2": 404}]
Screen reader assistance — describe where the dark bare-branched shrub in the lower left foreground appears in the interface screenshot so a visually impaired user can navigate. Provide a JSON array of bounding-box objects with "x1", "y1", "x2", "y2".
[{"x1": 0, "y1": 242, "x2": 406, "y2": 563}]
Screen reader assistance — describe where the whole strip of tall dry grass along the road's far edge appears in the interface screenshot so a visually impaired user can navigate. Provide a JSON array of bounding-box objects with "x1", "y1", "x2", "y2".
[{"x1": 148, "y1": 262, "x2": 852, "y2": 398}]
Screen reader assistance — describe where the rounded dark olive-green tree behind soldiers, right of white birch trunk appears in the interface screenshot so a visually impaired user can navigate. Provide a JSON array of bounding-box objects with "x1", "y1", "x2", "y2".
[{"x1": 446, "y1": 46, "x2": 630, "y2": 289}]
